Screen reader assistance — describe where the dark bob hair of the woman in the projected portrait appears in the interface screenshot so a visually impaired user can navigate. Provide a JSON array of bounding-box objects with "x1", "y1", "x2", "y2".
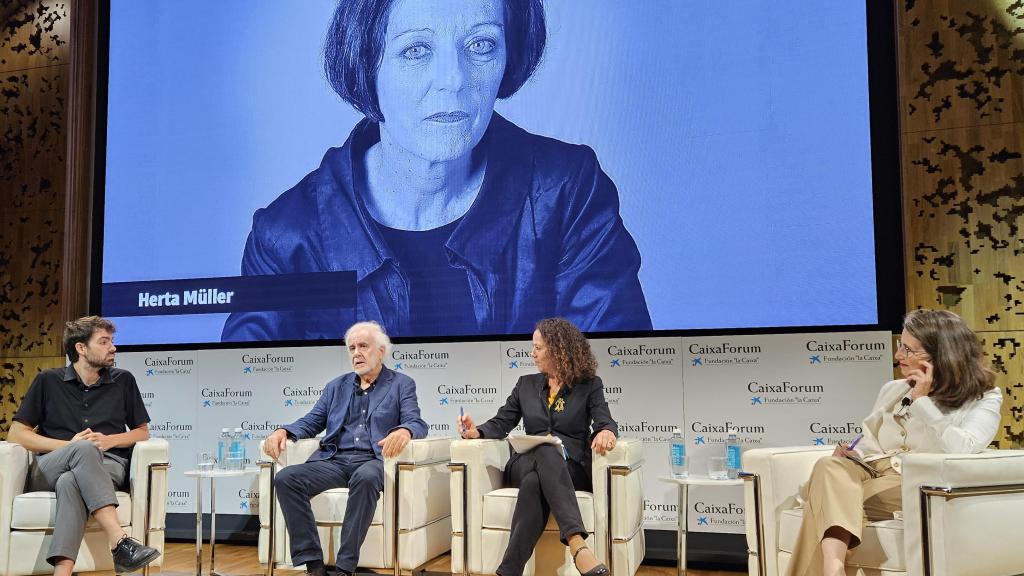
[{"x1": 324, "y1": 0, "x2": 547, "y2": 122}]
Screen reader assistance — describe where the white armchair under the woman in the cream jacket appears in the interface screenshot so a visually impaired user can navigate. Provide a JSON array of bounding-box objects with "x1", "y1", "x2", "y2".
[{"x1": 743, "y1": 447, "x2": 1024, "y2": 576}]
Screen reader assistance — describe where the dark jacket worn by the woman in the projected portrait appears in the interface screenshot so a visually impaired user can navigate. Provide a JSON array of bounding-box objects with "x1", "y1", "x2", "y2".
[{"x1": 222, "y1": 114, "x2": 651, "y2": 341}]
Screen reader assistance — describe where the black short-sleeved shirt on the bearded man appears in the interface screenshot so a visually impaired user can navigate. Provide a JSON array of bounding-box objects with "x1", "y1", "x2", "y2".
[{"x1": 14, "y1": 366, "x2": 150, "y2": 458}]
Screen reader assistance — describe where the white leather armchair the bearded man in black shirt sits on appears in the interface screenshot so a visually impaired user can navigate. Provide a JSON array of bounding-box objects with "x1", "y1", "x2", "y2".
[{"x1": 0, "y1": 439, "x2": 169, "y2": 576}]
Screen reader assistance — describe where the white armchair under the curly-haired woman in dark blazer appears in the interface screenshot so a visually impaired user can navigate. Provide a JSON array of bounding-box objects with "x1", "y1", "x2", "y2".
[{"x1": 450, "y1": 439, "x2": 644, "y2": 576}]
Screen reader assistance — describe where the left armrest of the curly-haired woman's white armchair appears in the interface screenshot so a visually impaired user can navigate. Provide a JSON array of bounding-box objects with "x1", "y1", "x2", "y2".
[{"x1": 450, "y1": 440, "x2": 509, "y2": 573}]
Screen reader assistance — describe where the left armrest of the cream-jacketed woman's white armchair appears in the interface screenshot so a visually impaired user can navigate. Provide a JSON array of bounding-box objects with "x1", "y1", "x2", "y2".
[{"x1": 742, "y1": 446, "x2": 835, "y2": 576}]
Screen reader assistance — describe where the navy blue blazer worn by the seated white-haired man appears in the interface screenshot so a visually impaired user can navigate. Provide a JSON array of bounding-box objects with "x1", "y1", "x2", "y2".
[{"x1": 281, "y1": 367, "x2": 427, "y2": 462}]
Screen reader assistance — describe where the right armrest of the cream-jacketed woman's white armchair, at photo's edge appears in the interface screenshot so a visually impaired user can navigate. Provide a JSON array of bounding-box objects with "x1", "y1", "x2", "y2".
[{"x1": 902, "y1": 450, "x2": 1024, "y2": 575}]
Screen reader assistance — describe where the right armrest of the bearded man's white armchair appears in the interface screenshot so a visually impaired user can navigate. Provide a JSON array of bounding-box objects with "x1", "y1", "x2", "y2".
[{"x1": 128, "y1": 438, "x2": 170, "y2": 549}]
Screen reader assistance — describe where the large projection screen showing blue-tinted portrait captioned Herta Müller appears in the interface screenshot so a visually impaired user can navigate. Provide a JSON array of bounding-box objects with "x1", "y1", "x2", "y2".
[{"x1": 97, "y1": 0, "x2": 896, "y2": 344}]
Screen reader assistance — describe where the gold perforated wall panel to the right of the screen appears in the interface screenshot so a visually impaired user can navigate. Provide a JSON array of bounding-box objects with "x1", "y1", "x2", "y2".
[{"x1": 899, "y1": 0, "x2": 1024, "y2": 447}]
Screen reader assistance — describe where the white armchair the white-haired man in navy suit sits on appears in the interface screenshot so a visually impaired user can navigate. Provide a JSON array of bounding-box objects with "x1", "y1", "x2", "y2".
[{"x1": 258, "y1": 438, "x2": 452, "y2": 575}]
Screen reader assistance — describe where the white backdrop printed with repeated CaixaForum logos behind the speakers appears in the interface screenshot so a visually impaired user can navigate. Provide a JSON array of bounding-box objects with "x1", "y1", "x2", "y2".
[{"x1": 118, "y1": 332, "x2": 892, "y2": 533}]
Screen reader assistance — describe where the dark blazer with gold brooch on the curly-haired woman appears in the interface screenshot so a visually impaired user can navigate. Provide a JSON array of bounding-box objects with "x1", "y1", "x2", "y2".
[{"x1": 477, "y1": 374, "x2": 618, "y2": 490}]
